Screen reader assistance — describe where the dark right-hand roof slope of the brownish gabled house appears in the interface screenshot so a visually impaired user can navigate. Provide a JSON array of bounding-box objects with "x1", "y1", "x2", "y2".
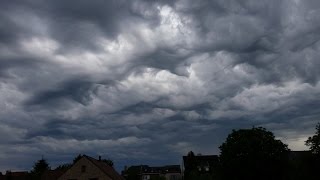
[{"x1": 83, "y1": 155, "x2": 124, "y2": 180}]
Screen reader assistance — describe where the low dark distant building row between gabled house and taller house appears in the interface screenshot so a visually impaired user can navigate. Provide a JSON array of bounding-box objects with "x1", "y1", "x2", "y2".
[{"x1": 122, "y1": 165, "x2": 182, "y2": 180}]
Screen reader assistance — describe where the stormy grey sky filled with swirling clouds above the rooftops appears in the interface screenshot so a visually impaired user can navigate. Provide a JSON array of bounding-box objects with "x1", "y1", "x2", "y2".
[{"x1": 0, "y1": 0, "x2": 320, "y2": 172}]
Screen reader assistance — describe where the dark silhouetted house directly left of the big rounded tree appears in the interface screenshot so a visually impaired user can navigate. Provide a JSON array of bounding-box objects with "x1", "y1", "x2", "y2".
[{"x1": 183, "y1": 152, "x2": 219, "y2": 180}]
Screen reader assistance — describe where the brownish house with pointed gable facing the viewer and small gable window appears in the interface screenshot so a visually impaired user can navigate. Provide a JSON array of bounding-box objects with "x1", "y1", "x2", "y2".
[{"x1": 58, "y1": 155, "x2": 124, "y2": 180}]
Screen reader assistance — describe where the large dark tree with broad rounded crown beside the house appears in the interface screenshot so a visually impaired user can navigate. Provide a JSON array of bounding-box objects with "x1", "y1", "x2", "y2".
[{"x1": 219, "y1": 127, "x2": 289, "y2": 180}]
